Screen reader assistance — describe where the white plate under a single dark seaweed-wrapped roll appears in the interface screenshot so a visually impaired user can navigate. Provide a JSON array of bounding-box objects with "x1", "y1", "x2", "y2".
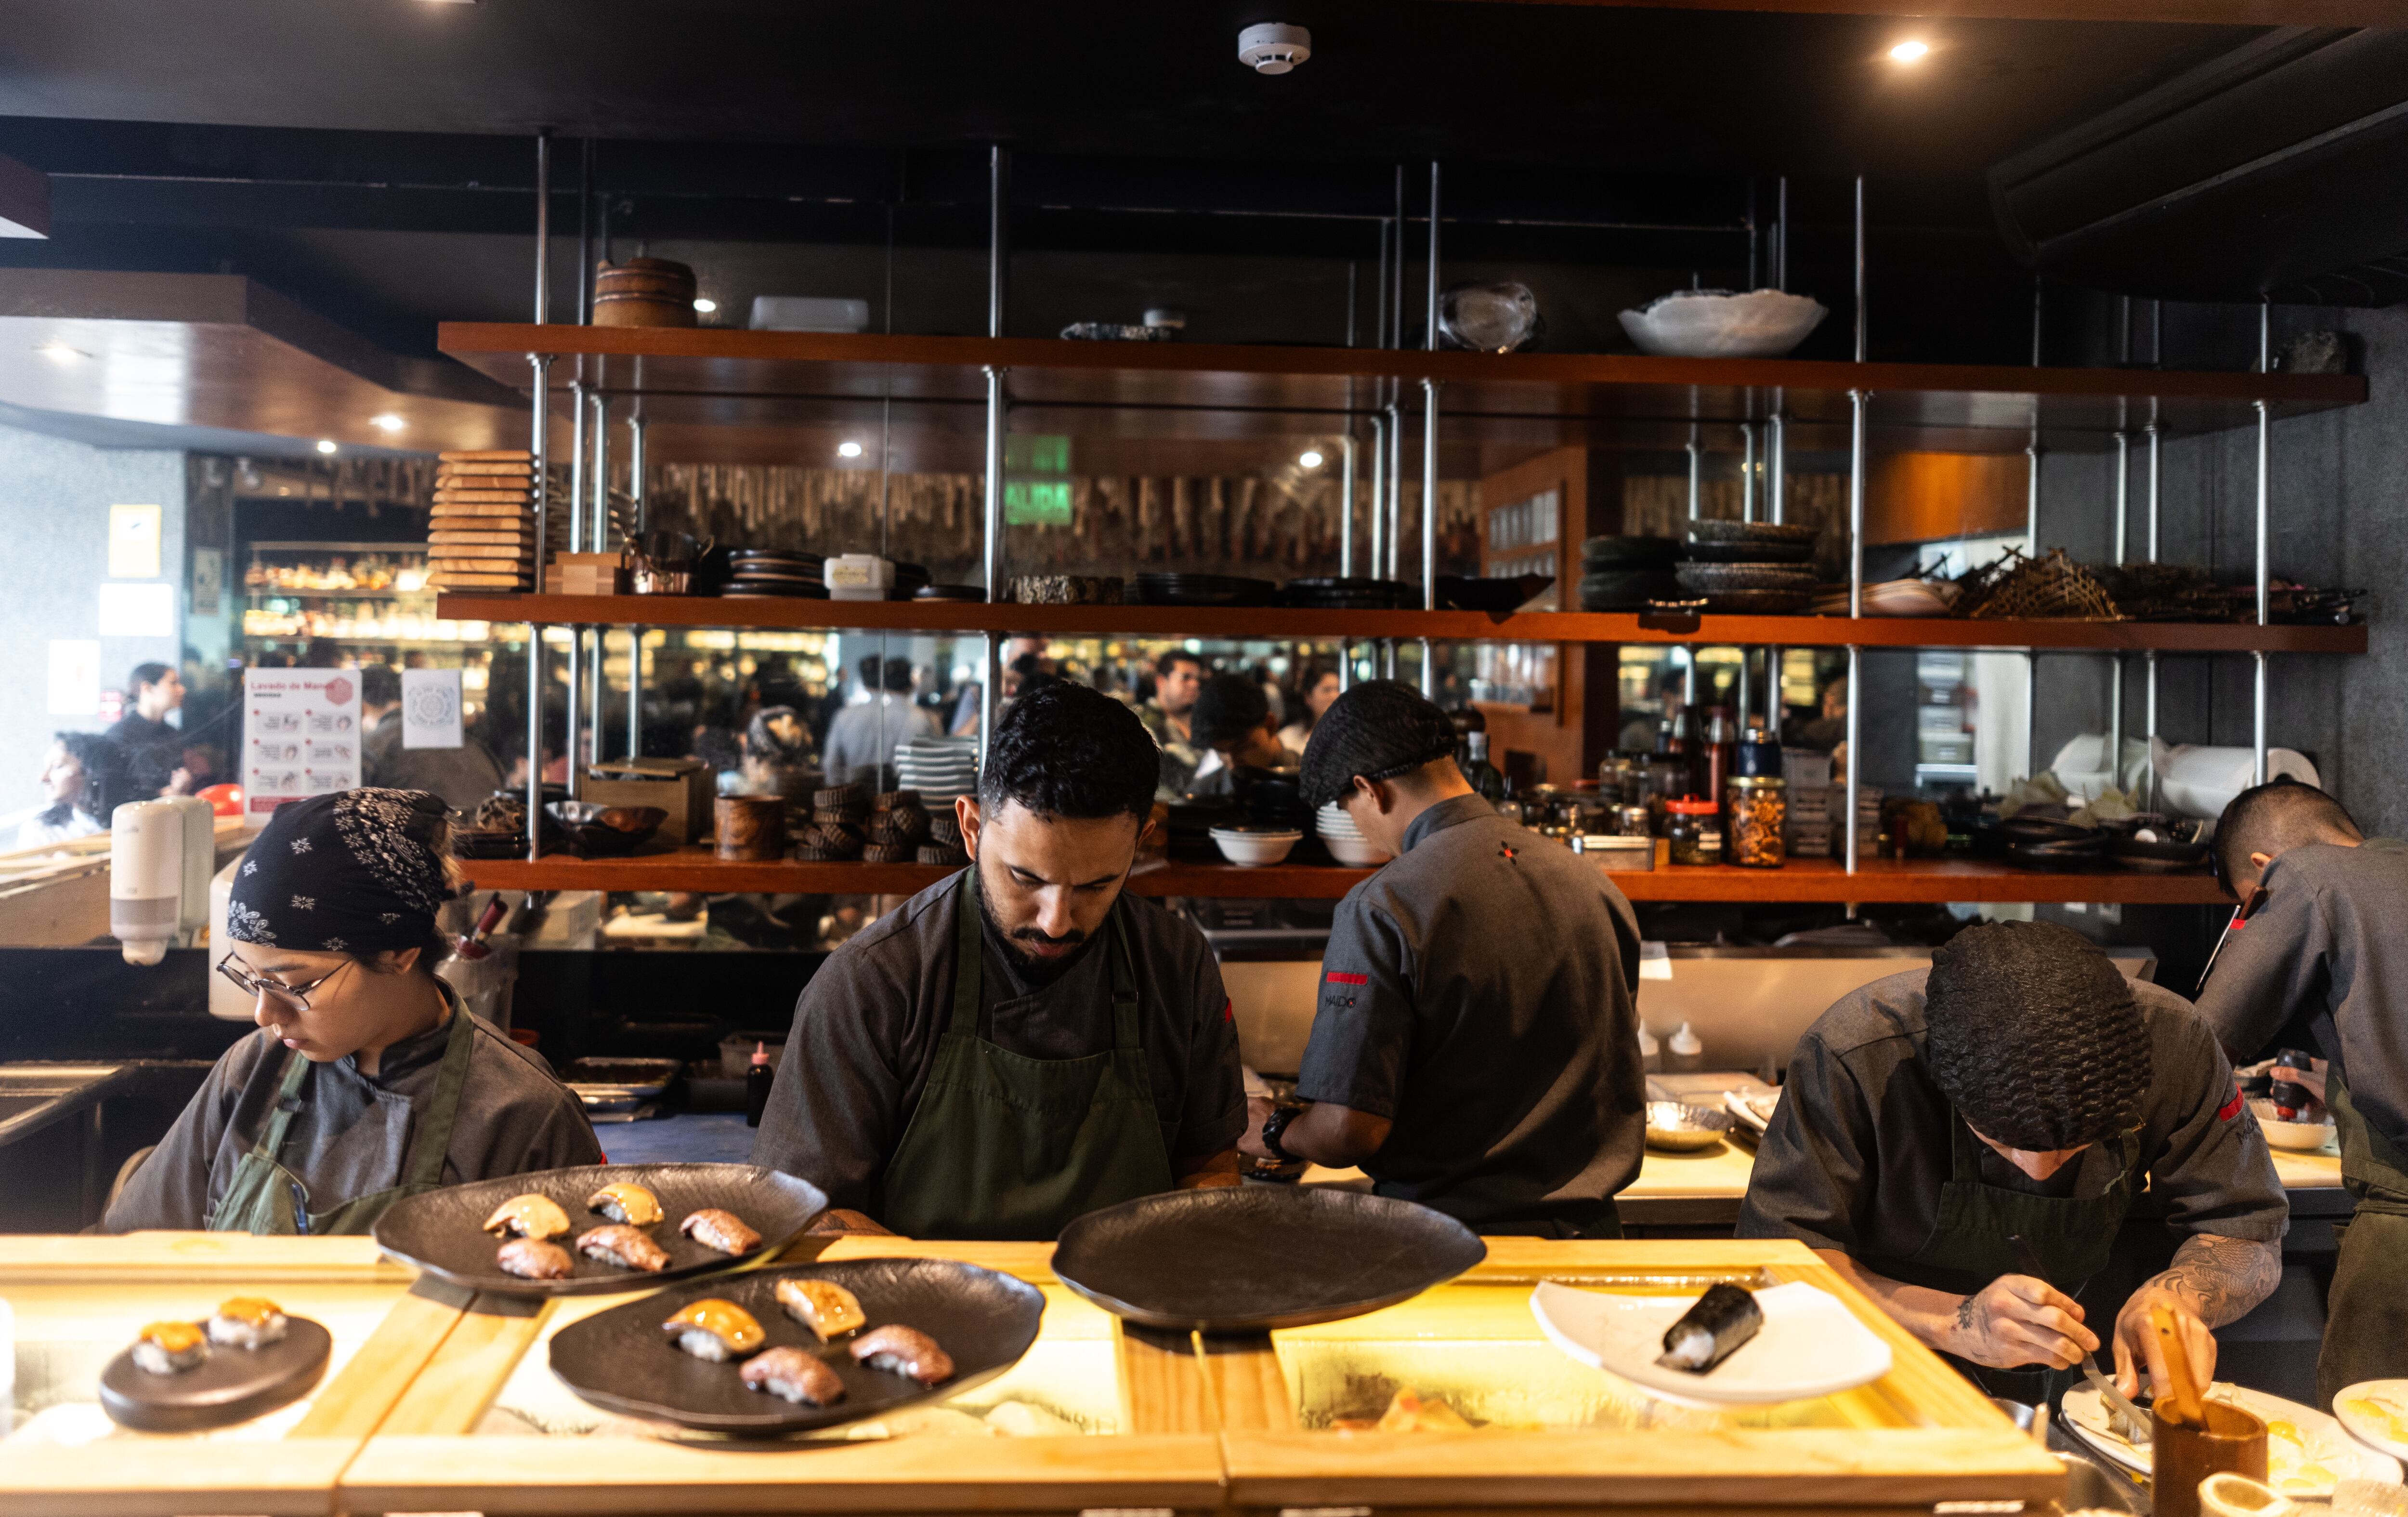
[{"x1": 1529, "y1": 1281, "x2": 1890, "y2": 1406}]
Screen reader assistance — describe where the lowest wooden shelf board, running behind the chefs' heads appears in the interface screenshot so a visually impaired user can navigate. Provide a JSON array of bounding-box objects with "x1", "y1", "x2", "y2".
[{"x1": 460, "y1": 840, "x2": 2225, "y2": 905}]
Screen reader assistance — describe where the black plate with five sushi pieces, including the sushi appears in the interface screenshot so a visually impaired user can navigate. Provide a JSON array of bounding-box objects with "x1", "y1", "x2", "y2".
[{"x1": 376, "y1": 1163, "x2": 828, "y2": 1295}]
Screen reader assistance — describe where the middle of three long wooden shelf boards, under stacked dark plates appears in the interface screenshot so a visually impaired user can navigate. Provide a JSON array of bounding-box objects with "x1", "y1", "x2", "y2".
[{"x1": 436, "y1": 595, "x2": 2367, "y2": 653}]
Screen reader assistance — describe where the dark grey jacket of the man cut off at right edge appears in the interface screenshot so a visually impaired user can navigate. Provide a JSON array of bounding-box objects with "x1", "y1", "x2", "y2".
[{"x1": 2199, "y1": 838, "x2": 2408, "y2": 1151}]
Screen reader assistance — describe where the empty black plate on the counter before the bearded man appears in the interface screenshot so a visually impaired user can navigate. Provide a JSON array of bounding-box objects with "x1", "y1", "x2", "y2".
[{"x1": 1052, "y1": 1185, "x2": 1488, "y2": 1332}]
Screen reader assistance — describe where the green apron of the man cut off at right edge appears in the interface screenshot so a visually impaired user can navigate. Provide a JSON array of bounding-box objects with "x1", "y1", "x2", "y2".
[{"x1": 2316, "y1": 1062, "x2": 2408, "y2": 1411}]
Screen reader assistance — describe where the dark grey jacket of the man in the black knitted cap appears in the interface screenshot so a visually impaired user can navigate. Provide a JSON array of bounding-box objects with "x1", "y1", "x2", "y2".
[{"x1": 1739, "y1": 968, "x2": 2290, "y2": 1274}]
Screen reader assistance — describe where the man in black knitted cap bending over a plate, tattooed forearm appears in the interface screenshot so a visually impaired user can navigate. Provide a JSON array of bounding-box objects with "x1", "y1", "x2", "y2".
[{"x1": 1739, "y1": 922, "x2": 2290, "y2": 1401}]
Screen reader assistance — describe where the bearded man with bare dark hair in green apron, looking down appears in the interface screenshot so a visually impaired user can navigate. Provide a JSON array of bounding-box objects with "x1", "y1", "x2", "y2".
[{"x1": 754, "y1": 684, "x2": 1245, "y2": 1238}]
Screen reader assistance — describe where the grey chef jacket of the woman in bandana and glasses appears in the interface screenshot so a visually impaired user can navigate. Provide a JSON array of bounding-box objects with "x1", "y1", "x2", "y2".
[{"x1": 101, "y1": 987, "x2": 602, "y2": 1233}]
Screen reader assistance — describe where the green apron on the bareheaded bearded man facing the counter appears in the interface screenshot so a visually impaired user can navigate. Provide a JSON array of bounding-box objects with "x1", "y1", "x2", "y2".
[{"x1": 879, "y1": 864, "x2": 1170, "y2": 1240}]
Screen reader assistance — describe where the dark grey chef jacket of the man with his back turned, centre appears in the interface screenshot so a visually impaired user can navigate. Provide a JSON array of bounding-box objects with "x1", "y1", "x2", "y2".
[{"x1": 1296, "y1": 794, "x2": 1647, "y2": 1238}]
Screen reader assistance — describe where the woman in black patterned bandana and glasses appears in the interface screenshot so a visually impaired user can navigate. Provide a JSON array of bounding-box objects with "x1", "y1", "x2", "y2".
[{"x1": 101, "y1": 790, "x2": 602, "y2": 1233}]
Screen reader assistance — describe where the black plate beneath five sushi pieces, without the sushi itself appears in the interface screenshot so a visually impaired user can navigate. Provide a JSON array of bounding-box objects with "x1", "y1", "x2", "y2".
[{"x1": 376, "y1": 1163, "x2": 828, "y2": 1295}]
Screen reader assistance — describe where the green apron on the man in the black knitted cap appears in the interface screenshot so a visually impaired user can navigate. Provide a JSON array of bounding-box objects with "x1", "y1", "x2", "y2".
[{"x1": 1871, "y1": 1108, "x2": 2141, "y2": 1406}]
